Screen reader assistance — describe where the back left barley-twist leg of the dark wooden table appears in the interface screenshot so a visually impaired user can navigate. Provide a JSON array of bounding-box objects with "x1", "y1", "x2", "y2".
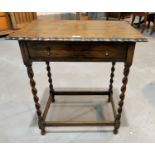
[{"x1": 46, "y1": 61, "x2": 55, "y2": 102}]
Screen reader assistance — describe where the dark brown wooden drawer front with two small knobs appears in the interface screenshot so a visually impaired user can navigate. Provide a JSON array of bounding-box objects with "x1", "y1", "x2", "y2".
[{"x1": 27, "y1": 42, "x2": 127, "y2": 61}]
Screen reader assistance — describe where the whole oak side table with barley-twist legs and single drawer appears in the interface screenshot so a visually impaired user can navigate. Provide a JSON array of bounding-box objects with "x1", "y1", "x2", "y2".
[{"x1": 7, "y1": 20, "x2": 147, "y2": 135}]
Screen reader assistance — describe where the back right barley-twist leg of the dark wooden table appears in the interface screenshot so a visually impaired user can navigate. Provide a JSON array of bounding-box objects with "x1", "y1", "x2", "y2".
[{"x1": 108, "y1": 62, "x2": 116, "y2": 102}]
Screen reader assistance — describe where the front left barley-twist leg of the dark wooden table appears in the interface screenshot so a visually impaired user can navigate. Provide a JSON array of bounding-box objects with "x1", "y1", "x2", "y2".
[{"x1": 26, "y1": 64, "x2": 45, "y2": 135}]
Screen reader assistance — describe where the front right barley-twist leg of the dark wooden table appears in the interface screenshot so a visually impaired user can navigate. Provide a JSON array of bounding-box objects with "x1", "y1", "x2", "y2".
[{"x1": 113, "y1": 64, "x2": 130, "y2": 134}]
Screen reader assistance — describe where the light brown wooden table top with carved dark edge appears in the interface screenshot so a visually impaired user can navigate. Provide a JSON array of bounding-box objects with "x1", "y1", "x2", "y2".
[{"x1": 7, "y1": 19, "x2": 147, "y2": 42}]
